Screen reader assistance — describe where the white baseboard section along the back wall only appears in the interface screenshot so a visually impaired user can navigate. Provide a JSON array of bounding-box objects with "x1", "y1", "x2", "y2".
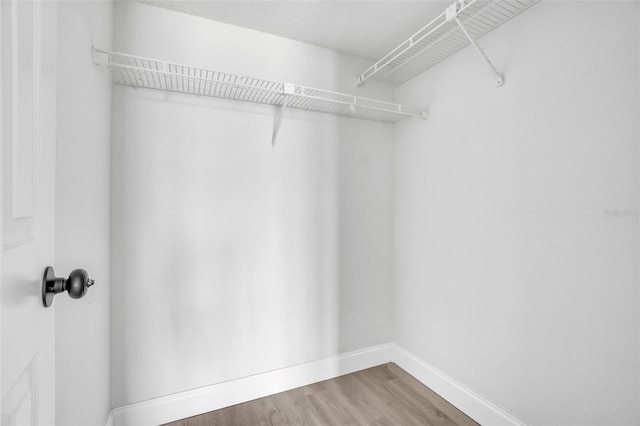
[{"x1": 108, "y1": 344, "x2": 394, "y2": 426}]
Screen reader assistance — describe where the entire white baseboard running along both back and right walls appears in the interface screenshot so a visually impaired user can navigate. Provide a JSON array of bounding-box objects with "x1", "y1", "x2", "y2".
[{"x1": 107, "y1": 343, "x2": 525, "y2": 426}]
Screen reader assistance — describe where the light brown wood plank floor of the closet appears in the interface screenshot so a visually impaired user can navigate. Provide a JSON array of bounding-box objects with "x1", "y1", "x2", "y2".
[{"x1": 169, "y1": 363, "x2": 477, "y2": 426}]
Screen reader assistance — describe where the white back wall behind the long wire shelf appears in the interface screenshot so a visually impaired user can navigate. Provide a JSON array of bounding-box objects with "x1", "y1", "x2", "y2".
[{"x1": 112, "y1": 2, "x2": 393, "y2": 406}]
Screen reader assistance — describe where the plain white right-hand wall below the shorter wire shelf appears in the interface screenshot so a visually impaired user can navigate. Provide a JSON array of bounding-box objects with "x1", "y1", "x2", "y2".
[{"x1": 394, "y1": 2, "x2": 640, "y2": 425}]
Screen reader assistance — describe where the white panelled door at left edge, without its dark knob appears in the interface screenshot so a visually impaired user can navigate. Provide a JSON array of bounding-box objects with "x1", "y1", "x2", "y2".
[{"x1": 0, "y1": 0, "x2": 57, "y2": 425}]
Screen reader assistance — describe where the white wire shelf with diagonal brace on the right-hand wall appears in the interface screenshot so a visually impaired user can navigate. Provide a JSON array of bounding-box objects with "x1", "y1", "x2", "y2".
[{"x1": 358, "y1": 0, "x2": 540, "y2": 86}]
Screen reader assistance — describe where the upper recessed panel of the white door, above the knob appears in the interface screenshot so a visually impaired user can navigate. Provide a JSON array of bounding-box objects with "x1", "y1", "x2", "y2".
[{"x1": 2, "y1": 0, "x2": 41, "y2": 250}]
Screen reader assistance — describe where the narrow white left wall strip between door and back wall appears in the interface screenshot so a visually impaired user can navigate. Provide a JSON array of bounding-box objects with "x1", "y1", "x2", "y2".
[{"x1": 53, "y1": 1, "x2": 113, "y2": 425}]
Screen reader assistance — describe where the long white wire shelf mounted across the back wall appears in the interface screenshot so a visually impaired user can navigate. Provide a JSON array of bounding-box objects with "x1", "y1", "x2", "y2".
[{"x1": 93, "y1": 48, "x2": 426, "y2": 123}]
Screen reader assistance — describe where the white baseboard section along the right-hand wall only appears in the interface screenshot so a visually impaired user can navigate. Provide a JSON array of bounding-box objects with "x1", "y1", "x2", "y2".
[{"x1": 392, "y1": 345, "x2": 524, "y2": 426}]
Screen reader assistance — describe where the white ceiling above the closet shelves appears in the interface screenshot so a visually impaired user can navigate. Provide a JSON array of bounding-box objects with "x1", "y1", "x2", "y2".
[{"x1": 141, "y1": 0, "x2": 452, "y2": 60}]
